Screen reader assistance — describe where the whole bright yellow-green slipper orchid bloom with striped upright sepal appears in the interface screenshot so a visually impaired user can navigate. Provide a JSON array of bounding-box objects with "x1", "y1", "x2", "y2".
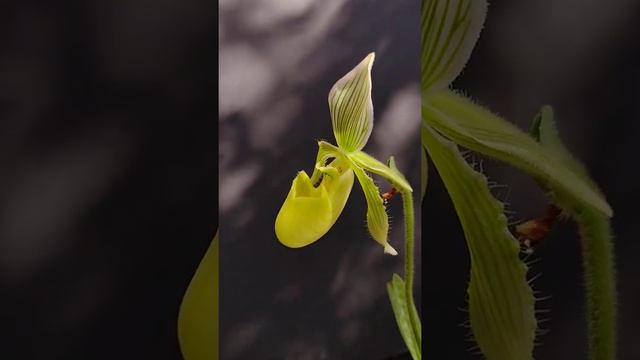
[{"x1": 275, "y1": 53, "x2": 413, "y2": 255}]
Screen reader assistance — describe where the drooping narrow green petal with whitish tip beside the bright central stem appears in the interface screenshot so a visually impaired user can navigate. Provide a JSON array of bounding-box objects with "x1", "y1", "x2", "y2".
[{"x1": 353, "y1": 166, "x2": 398, "y2": 255}]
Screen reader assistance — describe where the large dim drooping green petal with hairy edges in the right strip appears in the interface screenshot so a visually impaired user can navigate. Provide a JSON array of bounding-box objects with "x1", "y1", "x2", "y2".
[{"x1": 422, "y1": 126, "x2": 537, "y2": 360}]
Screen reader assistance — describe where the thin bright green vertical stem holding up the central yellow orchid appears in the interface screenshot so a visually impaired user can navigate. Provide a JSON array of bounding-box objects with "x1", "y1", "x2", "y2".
[{"x1": 401, "y1": 191, "x2": 422, "y2": 348}]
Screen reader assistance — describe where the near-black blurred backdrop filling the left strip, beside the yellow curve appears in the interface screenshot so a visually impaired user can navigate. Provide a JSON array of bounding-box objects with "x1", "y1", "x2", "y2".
[{"x1": 0, "y1": 0, "x2": 217, "y2": 360}]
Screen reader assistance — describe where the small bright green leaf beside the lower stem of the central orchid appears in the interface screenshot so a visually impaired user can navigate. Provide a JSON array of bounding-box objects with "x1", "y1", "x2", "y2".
[{"x1": 387, "y1": 274, "x2": 422, "y2": 360}]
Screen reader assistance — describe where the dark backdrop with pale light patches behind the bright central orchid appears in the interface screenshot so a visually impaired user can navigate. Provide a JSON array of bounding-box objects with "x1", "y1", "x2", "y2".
[{"x1": 219, "y1": 0, "x2": 420, "y2": 360}]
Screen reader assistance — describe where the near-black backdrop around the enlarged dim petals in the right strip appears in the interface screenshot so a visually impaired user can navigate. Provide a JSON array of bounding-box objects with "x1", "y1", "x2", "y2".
[{"x1": 422, "y1": 0, "x2": 640, "y2": 360}]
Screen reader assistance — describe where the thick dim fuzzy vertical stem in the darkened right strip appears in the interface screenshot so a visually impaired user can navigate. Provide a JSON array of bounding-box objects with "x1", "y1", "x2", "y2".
[{"x1": 577, "y1": 209, "x2": 617, "y2": 360}]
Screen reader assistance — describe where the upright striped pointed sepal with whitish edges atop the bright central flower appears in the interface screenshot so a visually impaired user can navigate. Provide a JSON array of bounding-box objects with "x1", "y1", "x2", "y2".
[{"x1": 329, "y1": 53, "x2": 375, "y2": 152}]
